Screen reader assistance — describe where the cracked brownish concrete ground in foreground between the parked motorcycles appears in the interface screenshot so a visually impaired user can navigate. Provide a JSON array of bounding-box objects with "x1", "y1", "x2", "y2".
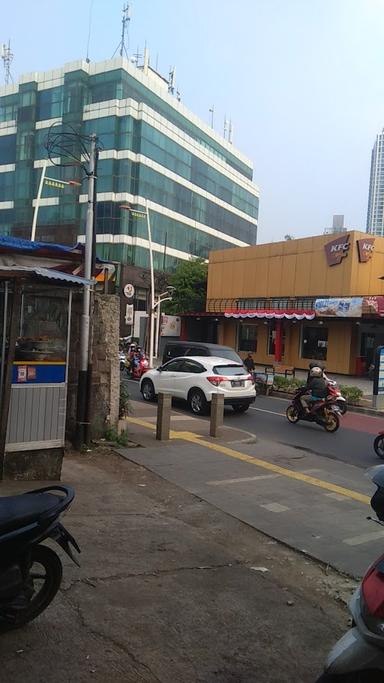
[{"x1": 0, "y1": 448, "x2": 353, "y2": 683}]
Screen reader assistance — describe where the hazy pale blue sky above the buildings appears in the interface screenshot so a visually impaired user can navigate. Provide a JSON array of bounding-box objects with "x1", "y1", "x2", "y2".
[{"x1": 0, "y1": 0, "x2": 384, "y2": 242}]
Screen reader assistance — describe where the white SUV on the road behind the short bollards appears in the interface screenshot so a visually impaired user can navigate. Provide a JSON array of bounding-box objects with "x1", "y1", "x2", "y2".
[{"x1": 140, "y1": 356, "x2": 256, "y2": 415}]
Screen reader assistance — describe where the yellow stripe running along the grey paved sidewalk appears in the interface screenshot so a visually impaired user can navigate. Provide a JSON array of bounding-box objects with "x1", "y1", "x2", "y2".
[{"x1": 125, "y1": 417, "x2": 372, "y2": 508}]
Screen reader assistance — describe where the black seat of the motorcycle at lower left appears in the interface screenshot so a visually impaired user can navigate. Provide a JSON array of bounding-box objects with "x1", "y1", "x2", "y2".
[{"x1": 0, "y1": 493, "x2": 62, "y2": 540}]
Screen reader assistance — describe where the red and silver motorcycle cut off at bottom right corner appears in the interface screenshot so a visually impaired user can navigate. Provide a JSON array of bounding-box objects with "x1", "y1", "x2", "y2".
[{"x1": 316, "y1": 465, "x2": 384, "y2": 683}]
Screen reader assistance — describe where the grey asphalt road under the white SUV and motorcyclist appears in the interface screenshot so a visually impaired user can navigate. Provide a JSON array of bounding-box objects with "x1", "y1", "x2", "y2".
[{"x1": 127, "y1": 380, "x2": 384, "y2": 469}]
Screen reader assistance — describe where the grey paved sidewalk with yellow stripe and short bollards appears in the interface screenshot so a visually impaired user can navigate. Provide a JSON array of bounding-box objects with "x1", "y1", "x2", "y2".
[{"x1": 120, "y1": 401, "x2": 384, "y2": 577}]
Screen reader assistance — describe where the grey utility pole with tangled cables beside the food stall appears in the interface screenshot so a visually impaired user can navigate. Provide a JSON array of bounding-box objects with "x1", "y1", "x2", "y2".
[{"x1": 77, "y1": 135, "x2": 97, "y2": 444}]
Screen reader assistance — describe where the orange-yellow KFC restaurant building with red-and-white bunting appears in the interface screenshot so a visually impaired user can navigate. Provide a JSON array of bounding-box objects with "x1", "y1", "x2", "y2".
[{"x1": 206, "y1": 231, "x2": 384, "y2": 375}]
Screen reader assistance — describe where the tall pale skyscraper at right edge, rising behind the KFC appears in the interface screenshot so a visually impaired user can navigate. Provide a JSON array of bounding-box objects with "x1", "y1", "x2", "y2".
[{"x1": 367, "y1": 128, "x2": 384, "y2": 237}]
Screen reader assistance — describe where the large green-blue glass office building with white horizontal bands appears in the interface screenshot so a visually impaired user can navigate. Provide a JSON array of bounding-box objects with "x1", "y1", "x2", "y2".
[{"x1": 0, "y1": 57, "x2": 259, "y2": 270}]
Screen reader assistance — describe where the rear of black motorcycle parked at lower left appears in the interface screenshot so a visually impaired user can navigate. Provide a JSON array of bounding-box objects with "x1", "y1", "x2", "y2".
[{"x1": 0, "y1": 486, "x2": 80, "y2": 633}]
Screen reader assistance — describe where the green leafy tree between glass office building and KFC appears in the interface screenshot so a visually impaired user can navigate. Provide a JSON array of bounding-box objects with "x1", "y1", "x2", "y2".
[{"x1": 166, "y1": 258, "x2": 208, "y2": 315}]
